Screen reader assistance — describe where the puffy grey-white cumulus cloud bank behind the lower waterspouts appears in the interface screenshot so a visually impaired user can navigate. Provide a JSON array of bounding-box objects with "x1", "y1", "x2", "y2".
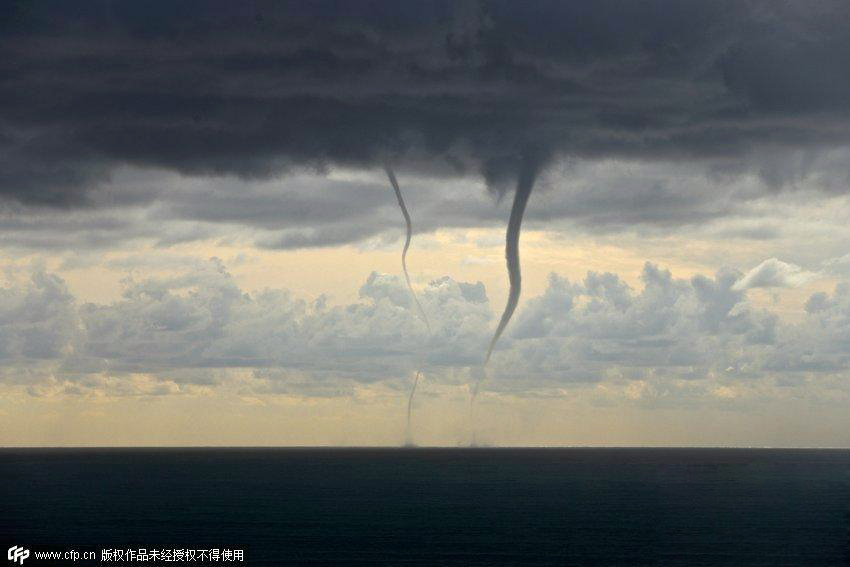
[{"x1": 0, "y1": 261, "x2": 850, "y2": 403}]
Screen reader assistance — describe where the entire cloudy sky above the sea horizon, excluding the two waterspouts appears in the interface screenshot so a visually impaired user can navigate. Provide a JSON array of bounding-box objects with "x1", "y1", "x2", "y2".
[{"x1": 0, "y1": 0, "x2": 850, "y2": 447}]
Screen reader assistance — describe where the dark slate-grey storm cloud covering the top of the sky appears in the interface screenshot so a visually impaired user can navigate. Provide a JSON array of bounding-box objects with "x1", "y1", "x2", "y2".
[{"x1": 0, "y1": 0, "x2": 850, "y2": 209}]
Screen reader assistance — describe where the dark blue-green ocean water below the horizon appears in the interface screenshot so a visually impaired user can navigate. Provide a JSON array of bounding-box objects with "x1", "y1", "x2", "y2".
[{"x1": 0, "y1": 449, "x2": 850, "y2": 567}]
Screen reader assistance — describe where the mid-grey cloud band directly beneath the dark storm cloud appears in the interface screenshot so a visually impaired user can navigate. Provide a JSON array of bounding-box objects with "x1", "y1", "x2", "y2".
[{"x1": 0, "y1": 152, "x2": 850, "y2": 255}]
